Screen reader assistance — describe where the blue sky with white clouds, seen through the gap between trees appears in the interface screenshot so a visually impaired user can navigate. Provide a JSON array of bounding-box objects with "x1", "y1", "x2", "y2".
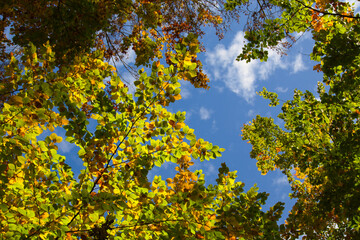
[{"x1": 50, "y1": 2, "x2": 359, "y2": 223}]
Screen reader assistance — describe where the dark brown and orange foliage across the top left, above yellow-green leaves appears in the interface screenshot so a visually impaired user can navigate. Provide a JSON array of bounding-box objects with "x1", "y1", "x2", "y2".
[{"x1": 0, "y1": 0, "x2": 242, "y2": 88}]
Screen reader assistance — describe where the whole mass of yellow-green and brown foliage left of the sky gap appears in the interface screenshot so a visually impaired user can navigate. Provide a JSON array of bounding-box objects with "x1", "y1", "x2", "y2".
[{"x1": 0, "y1": 0, "x2": 283, "y2": 239}]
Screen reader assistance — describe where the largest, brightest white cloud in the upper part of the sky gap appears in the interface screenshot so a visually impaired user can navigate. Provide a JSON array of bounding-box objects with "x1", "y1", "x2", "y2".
[{"x1": 207, "y1": 31, "x2": 287, "y2": 102}]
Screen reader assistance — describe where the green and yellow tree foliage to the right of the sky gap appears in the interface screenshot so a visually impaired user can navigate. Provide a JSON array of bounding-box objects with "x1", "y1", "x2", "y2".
[{"x1": 235, "y1": 0, "x2": 360, "y2": 239}]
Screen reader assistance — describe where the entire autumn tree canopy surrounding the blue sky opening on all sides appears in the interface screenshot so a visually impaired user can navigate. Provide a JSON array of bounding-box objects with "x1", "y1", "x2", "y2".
[{"x1": 0, "y1": 0, "x2": 360, "y2": 239}]
